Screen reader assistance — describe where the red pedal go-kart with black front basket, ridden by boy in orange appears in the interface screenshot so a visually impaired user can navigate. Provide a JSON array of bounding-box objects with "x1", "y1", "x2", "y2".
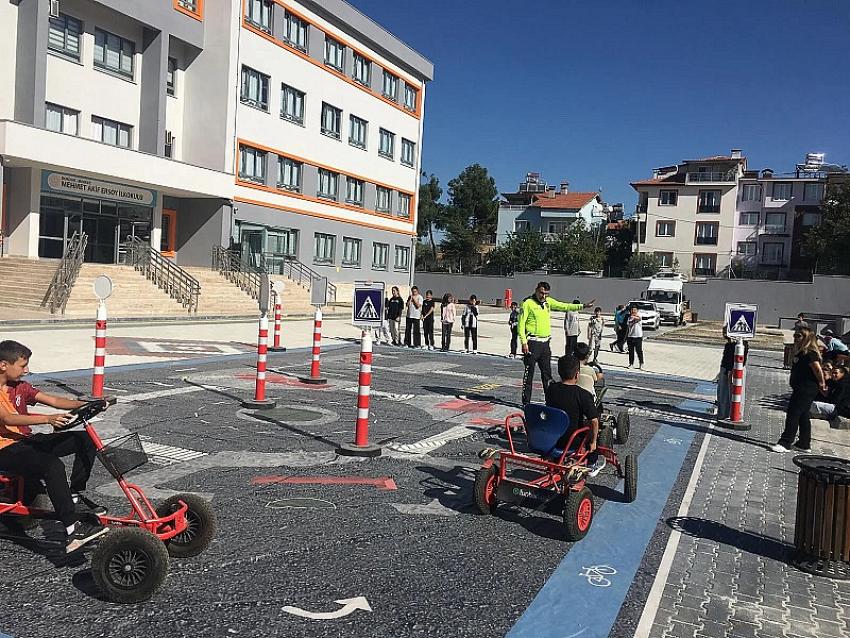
[{"x1": 0, "y1": 401, "x2": 216, "y2": 603}]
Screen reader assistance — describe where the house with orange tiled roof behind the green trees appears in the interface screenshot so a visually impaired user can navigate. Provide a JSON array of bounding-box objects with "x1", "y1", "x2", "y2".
[{"x1": 496, "y1": 173, "x2": 611, "y2": 245}]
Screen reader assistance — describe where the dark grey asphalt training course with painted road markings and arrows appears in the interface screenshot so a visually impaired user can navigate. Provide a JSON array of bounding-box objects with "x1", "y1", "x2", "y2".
[{"x1": 0, "y1": 345, "x2": 716, "y2": 638}]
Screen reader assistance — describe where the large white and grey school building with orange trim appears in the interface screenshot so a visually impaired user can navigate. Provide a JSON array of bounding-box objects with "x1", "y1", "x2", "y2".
[{"x1": 0, "y1": 0, "x2": 433, "y2": 283}]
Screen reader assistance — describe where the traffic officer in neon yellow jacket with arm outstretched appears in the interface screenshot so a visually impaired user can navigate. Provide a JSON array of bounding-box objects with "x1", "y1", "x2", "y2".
[{"x1": 517, "y1": 281, "x2": 596, "y2": 405}]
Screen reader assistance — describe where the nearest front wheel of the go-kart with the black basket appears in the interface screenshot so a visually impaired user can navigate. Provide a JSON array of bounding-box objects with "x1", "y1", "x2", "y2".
[{"x1": 91, "y1": 527, "x2": 168, "y2": 603}]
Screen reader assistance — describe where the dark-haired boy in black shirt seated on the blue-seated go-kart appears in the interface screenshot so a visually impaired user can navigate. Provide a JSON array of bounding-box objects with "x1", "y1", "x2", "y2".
[{"x1": 546, "y1": 355, "x2": 605, "y2": 476}]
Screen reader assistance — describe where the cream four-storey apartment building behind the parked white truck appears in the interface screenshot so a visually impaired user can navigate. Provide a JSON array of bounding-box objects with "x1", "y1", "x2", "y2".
[{"x1": 631, "y1": 149, "x2": 747, "y2": 276}]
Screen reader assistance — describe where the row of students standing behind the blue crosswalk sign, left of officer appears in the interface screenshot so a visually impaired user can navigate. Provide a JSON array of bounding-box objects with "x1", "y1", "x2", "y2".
[{"x1": 375, "y1": 286, "x2": 479, "y2": 354}]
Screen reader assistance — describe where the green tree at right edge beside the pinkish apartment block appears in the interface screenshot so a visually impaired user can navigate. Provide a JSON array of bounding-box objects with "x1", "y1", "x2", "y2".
[{"x1": 804, "y1": 180, "x2": 850, "y2": 275}]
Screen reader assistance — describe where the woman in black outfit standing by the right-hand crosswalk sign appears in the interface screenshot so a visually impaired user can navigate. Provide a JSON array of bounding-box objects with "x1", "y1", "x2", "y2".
[{"x1": 771, "y1": 328, "x2": 826, "y2": 452}]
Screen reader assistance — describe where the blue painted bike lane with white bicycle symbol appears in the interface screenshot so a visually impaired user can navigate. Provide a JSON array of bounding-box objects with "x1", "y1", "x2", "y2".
[{"x1": 507, "y1": 383, "x2": 715, "y2": 638}]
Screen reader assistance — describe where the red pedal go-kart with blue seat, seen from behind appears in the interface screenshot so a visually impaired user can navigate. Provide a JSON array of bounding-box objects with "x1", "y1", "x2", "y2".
[{"x1": 474, "y1": 403, "x2": 637, "y2": 541}]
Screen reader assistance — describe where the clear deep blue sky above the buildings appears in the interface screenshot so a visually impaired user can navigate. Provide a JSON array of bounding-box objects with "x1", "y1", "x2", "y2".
[{"x1": 350, "y1": 0, "x2": 850, "y2": 214}]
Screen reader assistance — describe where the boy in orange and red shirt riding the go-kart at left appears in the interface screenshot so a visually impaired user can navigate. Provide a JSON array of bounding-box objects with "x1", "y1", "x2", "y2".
[{"x1": 0, "y1": 341, "x2": 109, "y2": 552}]
